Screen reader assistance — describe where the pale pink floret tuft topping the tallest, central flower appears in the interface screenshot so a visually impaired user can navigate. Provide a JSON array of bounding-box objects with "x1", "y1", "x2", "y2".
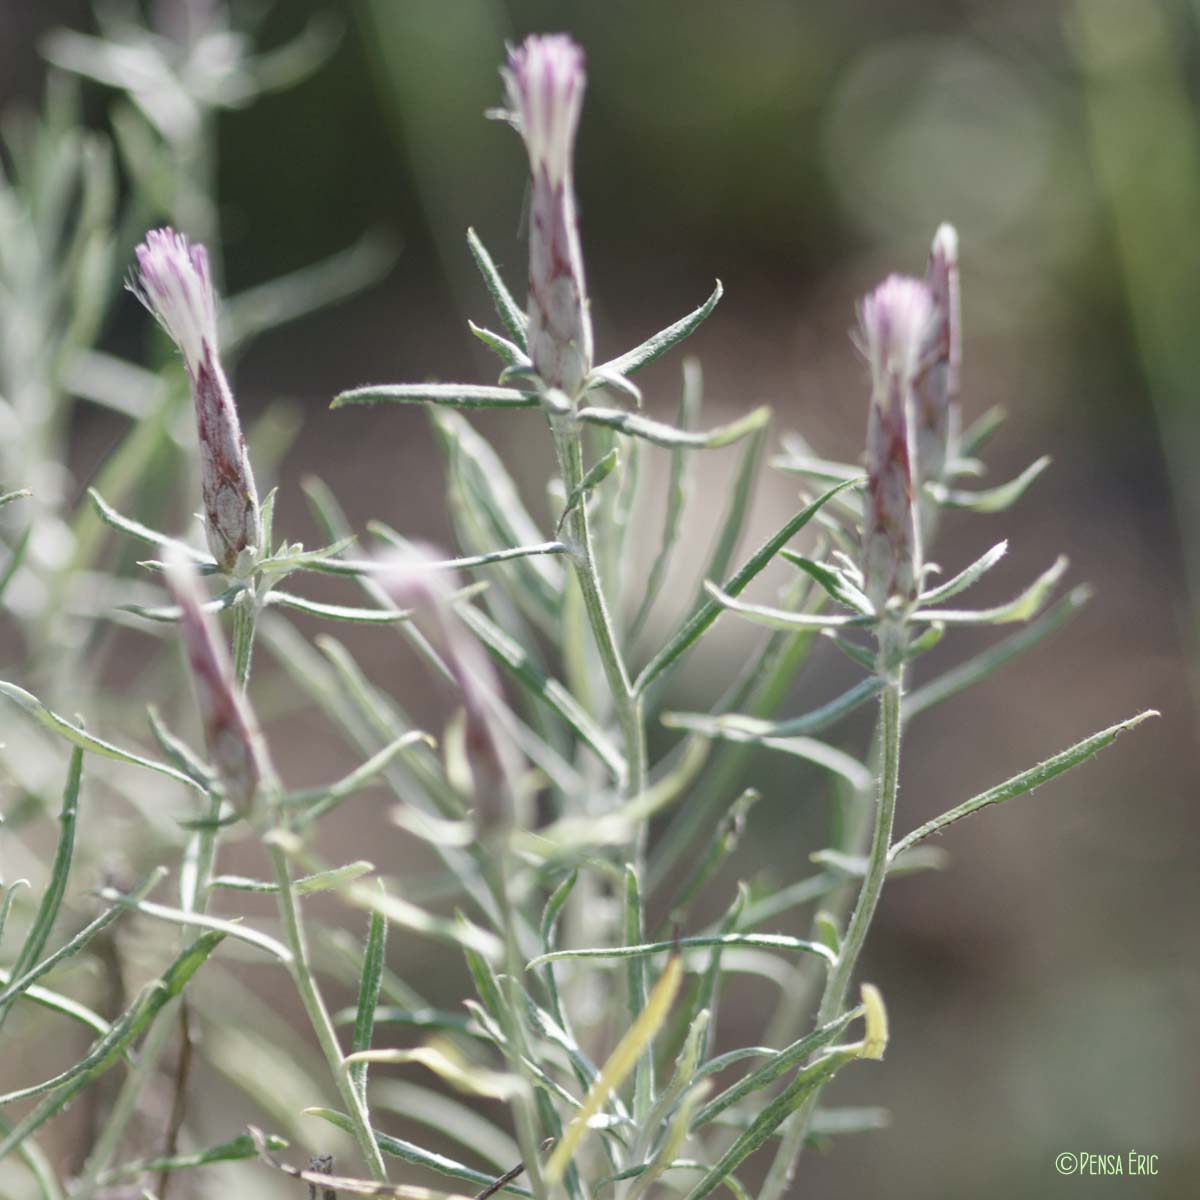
[{"x1": 500, "y1": 34, "x2": 587, "y2": 186}]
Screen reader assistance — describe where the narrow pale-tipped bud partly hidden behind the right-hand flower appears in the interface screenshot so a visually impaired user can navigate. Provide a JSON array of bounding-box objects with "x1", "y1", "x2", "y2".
[{"x1": 916, "y1": 224, "x2": 962, "y2": 484}]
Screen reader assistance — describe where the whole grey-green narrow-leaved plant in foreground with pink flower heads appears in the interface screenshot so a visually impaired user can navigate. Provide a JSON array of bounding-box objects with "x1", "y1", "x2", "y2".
[{"x1": 0, "y1": 18, "x2": 1150, "y2": 1200}]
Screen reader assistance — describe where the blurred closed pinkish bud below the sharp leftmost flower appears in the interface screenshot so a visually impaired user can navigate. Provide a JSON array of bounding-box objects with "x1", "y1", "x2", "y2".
[{"x1": 167, "y1": 552, "x2": 269, "y2": 816}]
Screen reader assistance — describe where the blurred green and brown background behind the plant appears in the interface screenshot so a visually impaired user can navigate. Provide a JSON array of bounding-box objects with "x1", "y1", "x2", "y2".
[{"x1": 0, "y1": 0, "x2": 1200, "y2": 1200}]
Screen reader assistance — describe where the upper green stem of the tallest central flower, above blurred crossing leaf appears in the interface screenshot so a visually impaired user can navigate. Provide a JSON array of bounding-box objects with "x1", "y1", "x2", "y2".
[{"x1": 550, "y1": 414, "x2": 646, "y2": 797}]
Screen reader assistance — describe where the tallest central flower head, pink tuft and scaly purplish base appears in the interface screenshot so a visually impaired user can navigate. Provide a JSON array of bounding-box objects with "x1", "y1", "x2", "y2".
[{"x1": 500, "y1": 34, "x2": 592, "y2": 398}]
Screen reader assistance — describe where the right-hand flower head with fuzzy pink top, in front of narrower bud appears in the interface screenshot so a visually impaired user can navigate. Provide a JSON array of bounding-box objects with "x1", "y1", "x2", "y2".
[{"x1": 859, "y1": 275, "x2": 937, "y2": 611}]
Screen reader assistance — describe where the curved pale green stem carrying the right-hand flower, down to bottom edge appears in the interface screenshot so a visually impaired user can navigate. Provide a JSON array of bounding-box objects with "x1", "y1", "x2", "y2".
[{"x1": 758, "y1": 657, "x2": 904, "y2": 1200}]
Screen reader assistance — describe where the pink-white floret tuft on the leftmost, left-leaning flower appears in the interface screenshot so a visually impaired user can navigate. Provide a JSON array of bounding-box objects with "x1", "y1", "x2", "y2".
[{"x1": 130, "y1": 227, "x2": 217, "y2": 379}]
